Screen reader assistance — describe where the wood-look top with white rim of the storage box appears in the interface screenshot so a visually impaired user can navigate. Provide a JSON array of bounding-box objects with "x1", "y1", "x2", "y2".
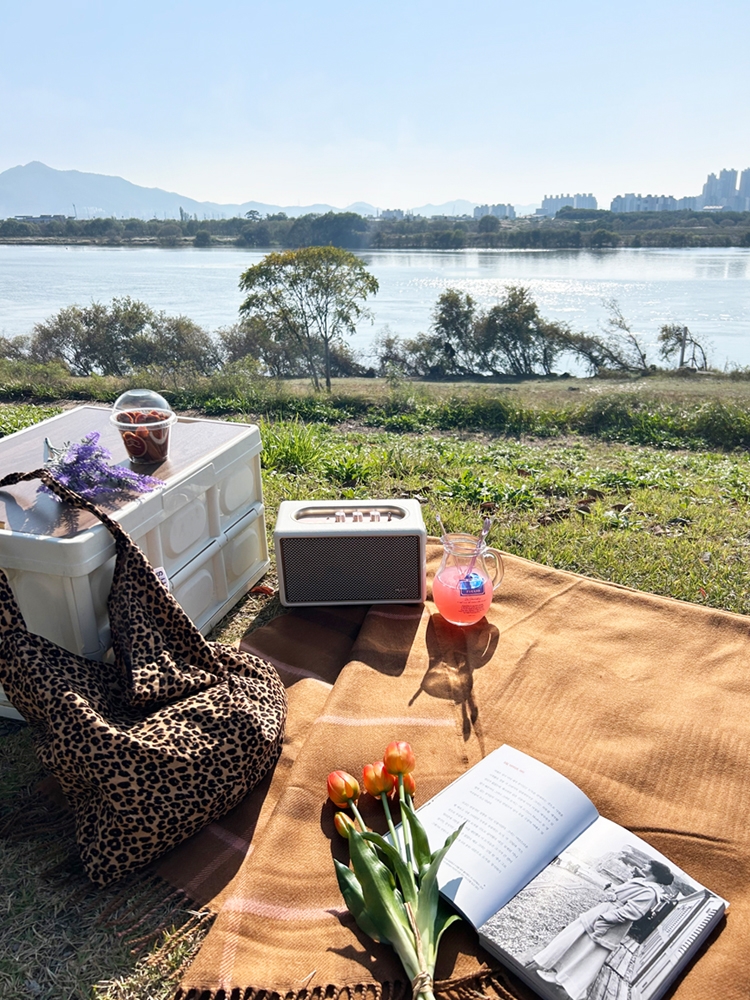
[{"x1": 0, "y1": 406, "x2": 261, "y2": 576}]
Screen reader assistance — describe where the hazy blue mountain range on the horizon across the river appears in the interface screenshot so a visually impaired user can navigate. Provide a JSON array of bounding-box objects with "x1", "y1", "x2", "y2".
[{"x1": 0, "y1": 161, "x2": 490, "y2": 219}]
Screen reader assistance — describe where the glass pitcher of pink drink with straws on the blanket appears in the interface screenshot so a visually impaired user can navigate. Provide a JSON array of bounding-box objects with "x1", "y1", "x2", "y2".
[{"x1": 432, "y1": 534, "x2": 505, "y2": 625}]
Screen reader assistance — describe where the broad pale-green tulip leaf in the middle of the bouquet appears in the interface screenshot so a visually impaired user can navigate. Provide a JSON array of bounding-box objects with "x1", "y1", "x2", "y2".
[{"x1": 349, "y1": 831, "x2": 419, "y2": 979}]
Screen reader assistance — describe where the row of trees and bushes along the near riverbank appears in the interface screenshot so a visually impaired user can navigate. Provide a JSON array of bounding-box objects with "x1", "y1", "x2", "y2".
[{"x1": 0, "y1": 246, "x2": 708, "y2": 391}]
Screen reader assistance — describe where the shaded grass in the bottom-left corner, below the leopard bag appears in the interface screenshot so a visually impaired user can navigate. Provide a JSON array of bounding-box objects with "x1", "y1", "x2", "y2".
[{"x1": 0, "y1": 727, "x2": 212, "y2": 1000}]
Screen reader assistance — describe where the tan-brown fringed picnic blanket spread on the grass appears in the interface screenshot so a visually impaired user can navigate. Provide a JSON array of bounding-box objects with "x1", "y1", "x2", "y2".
[{"x1": 178, "y1": 544, "x2": 750, "y2": 1000}]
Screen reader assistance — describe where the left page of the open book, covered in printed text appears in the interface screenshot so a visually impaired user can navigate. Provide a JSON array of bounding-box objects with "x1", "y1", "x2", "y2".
[{"x1": 419, "y1": 746, "x2": 597, "y2": 927}]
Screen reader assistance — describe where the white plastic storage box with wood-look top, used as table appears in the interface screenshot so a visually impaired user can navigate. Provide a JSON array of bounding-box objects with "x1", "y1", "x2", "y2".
[{"x1": 0, "y1": 406, "x2": 269, "y2": 717}]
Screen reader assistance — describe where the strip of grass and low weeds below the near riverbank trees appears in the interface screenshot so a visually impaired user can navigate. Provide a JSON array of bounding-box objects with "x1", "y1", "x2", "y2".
[{"x1": 7, "y1": 372, "x2": 750, "y2": 450}]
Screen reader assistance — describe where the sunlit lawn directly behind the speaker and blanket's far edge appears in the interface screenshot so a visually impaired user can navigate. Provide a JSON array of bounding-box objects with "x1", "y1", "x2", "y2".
[{"x1": 264, "y1": 431, "x2": 750, "y2": 614}]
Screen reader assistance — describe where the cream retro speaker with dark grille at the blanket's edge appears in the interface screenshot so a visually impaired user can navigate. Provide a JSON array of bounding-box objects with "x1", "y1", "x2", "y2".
[{"x1": 273, "y1": 500, "x2": 427, "y2": 607}]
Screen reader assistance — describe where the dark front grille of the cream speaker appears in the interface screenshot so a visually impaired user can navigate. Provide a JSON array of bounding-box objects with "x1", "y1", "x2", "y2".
[{"x1": 279, "y1": 535, "x2": 422, "y2": 604}]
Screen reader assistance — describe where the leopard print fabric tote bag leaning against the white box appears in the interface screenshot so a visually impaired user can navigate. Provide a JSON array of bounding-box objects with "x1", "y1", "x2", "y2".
[{"x1": 0, "y1": 469, "x2": 286, "y2": 886}]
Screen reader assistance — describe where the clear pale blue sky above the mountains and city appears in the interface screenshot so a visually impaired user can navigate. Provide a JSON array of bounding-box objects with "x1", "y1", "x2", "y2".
[{"x1": 0, "y1": 0, "x2": 750, "y2": 209}]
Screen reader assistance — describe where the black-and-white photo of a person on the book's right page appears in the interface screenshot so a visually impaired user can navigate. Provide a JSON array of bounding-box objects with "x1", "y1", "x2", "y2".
[{"x1": 479, "y1": 817, "x2": 724, "y2": 1000}]
